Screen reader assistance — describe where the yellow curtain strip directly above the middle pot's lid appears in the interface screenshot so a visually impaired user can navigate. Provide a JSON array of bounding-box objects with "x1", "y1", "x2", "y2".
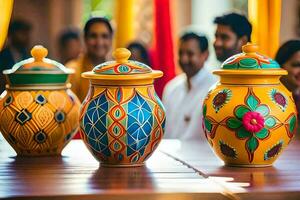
[{"x1": 115, "y1": 0, "x2": 134, "y2": 48}]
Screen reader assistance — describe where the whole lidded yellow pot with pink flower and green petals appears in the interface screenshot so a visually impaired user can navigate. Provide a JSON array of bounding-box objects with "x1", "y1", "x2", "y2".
[{"x1": 203, "y1": 44, "x2": 297, "y2": 167}]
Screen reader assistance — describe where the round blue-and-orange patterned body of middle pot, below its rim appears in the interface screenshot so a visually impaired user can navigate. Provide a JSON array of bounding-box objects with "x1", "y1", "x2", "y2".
[{"x1": 80, "y1": 86, "x2": 165, "y2": 165}]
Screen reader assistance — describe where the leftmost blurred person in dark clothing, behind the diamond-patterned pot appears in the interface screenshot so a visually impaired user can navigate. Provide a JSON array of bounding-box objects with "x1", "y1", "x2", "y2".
[{"x1": 0, "y1": 19, "x2": 32, "y2": 93}]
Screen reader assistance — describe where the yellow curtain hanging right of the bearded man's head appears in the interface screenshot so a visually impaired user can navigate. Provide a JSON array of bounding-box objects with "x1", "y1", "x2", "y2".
[{"x1": 248, "y1": 0, "x2": 281, "y2": 57}]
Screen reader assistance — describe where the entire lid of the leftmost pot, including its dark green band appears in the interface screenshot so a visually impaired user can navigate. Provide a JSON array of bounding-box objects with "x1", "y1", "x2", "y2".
[{"x1": 3, "y1": 45, "x2": 74, "y2": 86}]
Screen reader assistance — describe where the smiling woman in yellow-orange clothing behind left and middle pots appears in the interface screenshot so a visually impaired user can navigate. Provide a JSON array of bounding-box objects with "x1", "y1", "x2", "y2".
[{"x1": 66, "y1": 17, "x2": 113, "y2": 101}]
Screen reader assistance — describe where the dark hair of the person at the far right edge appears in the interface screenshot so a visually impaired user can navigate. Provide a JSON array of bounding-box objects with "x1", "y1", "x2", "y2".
[{"x1": 275, "y1": 40, "x2": 300, "y2": 65}]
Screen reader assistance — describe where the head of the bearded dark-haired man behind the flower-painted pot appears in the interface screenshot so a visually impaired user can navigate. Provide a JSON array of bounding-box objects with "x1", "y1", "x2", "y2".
[{"x1": 214, "y1": 13, "x2": 252, "y2": 62}]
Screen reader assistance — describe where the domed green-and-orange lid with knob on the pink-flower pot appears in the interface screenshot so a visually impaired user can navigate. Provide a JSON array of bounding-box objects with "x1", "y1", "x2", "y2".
[{"x1": 221, "y1": 43, "x2": 280, "y2": 70}]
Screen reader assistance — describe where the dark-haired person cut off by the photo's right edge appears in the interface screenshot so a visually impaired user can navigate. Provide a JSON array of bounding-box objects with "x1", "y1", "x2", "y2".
[{"x1": 275, "y1": 40, "x2": 300, "y2": 118}]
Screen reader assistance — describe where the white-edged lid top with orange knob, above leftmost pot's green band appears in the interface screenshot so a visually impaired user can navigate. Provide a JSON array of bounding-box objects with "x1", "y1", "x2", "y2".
[{"x1": 3, "y1": 45, "x2": 74, "y2": 75}]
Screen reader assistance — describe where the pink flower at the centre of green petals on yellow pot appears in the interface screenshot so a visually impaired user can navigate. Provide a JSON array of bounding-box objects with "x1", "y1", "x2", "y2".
[{"x1": 242, "y1": 111, "x2": 265, "y2": 133}]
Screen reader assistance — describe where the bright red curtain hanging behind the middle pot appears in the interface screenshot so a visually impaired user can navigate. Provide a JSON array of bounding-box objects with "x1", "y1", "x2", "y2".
[{"x1": 152, "y1": 0, "x2": 175, "y2": 97}]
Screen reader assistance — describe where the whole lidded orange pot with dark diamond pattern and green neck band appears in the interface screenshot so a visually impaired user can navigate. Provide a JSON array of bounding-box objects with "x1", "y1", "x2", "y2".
[{"x1": 0, "y1": 46, "x2": 80, "y2": 156}]
